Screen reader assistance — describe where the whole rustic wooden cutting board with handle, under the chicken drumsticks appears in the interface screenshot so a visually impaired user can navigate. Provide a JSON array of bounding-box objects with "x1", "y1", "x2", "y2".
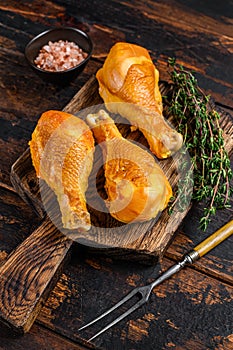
[{"x1": 0, "y1": 77, "x2": 232, "y2": 333}]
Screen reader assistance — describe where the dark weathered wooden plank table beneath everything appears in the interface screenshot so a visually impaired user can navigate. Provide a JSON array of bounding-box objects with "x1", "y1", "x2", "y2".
[{"x1": 0, "y1": 0, "x2": 233, "y2": 350}]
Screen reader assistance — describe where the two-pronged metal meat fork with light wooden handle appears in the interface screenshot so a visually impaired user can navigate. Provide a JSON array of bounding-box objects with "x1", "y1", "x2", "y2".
[{"x1": 79, "y1": 220, "x2": 233, "y2": 341}]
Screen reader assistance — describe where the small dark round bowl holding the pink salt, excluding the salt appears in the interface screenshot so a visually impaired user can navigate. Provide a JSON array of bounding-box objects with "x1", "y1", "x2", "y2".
[{"x1": 25, "y1": 27, "x2": 93, "y2": 85}]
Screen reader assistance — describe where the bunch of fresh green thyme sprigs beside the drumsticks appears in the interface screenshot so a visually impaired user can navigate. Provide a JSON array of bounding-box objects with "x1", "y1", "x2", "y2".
[{"x1": 168, "y1": 59, "x2": 232, "y2": 231}]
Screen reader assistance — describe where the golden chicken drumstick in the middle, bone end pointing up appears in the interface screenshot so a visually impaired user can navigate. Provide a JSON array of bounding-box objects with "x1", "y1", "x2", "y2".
[{"x1": 86, "y1": 110, "x2": 172, "y2": 223}]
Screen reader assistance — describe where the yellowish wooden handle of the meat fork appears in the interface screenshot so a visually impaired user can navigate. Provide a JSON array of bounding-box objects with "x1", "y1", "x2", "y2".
[{"x1": 193, "y1": 220, "x2": 233, "y2": 257}]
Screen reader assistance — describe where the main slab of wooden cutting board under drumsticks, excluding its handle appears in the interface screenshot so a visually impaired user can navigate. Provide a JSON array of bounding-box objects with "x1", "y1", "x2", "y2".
[{"x1": 11, "y1": 77, "x2": 193, "y2": 263}]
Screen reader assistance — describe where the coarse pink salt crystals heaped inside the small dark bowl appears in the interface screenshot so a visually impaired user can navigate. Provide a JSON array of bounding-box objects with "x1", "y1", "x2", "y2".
[{"x1": 34, "y1": 40, "x2": 88, "y2": 72}]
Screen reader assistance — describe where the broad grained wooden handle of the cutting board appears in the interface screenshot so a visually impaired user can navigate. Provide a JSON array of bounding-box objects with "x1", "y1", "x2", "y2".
[{"x1": 0, "y1": 219, "x2": 72, "y2": 333}]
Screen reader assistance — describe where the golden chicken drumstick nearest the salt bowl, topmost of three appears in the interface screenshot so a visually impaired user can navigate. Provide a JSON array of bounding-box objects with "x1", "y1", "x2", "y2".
[{"x1": 96, "y1": 42, "x2": 183, "y2": 158}]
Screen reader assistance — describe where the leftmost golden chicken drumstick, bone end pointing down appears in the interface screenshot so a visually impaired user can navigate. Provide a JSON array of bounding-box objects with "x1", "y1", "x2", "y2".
[{"x1": 29, "y1": 111, "x2": 94, "y2": 231}]
